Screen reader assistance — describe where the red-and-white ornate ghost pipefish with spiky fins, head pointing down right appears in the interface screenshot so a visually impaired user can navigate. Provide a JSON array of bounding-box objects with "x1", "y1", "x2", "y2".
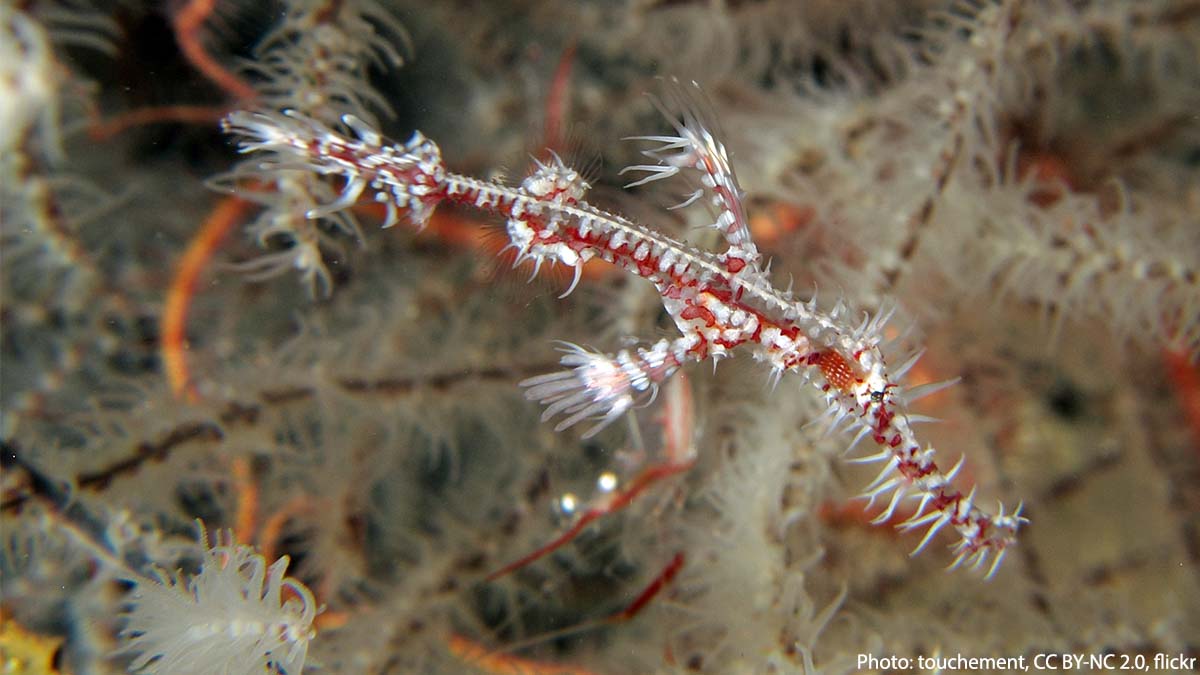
[{"x1": 224, "y1": 78, "x2": 1026, "y2": 575}]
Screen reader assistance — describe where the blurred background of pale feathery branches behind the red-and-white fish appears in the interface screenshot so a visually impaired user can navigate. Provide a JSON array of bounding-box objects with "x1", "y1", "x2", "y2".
[{"x1": 0, "y1": 0, "x2": 1200, "y2": 675}]
